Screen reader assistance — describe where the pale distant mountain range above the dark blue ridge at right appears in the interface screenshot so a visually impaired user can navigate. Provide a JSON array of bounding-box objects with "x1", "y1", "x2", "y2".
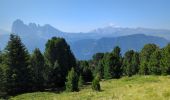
[{"x1": 89, "y1": 26, "x2": 170, "y2": 40}]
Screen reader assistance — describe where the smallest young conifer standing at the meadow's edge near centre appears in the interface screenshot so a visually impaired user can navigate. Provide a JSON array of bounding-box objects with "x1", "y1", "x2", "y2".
[{"x1": 92, "y1": 74, "x2": 101, "y2": 91}]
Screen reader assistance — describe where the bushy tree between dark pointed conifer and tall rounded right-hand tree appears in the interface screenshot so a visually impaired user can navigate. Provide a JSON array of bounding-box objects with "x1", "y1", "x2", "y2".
[{"x1": 122, "y1": 50, "x2": 139, "y2": 76}]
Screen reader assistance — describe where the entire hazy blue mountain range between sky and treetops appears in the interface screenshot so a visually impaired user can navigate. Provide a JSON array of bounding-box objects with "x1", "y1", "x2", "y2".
[{"x1": 0, "y1": 20, "x2": 170, "y2": 59}]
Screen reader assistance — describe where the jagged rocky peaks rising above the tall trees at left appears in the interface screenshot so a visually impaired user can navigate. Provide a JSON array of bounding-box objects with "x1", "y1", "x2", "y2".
[{"x1": 11, "y1": 19, "x2": 64, "y2": 38}]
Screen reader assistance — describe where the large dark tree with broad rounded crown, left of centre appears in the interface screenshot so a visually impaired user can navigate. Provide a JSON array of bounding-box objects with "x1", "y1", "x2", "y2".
[{"x1": 45, "y1": 37, "x2": 77, "y2": 87}]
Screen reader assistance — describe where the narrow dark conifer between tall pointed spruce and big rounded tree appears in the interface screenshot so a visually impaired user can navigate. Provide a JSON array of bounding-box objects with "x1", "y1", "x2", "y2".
[{"x1": 30, "y1": 48, "x2": 47, "y2": 90}]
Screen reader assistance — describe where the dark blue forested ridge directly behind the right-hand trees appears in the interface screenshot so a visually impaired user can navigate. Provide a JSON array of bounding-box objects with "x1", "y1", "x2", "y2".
[{"x1": 71, "y1": 34, "x2": 169, "y2": 59}]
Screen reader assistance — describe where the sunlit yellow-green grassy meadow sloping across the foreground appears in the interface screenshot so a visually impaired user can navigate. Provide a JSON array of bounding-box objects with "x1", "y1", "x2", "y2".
[{"x1": 11, "y1": 76, "x2": 170, "y2": 100}]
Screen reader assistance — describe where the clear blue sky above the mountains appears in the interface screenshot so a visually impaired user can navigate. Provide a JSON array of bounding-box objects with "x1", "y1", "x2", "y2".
[{"x1": 0, "y1": 0, "x2": 170, "y2": 32}]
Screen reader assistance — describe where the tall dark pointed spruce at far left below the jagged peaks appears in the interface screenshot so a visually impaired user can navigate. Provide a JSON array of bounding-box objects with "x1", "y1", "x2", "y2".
[{"x1": 6, "y1": 34, "x2": 31, "y2": 94}]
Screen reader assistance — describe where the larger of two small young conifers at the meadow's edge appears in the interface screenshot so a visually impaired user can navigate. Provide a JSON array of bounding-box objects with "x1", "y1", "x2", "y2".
[{"x1": 65, "y1": 68, "x2": 79, "y2": 92}]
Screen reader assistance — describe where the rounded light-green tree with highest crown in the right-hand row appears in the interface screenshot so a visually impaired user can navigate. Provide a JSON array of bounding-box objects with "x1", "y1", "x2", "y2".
[{"x1": 139, "y1": 44, "x2": 159, "y2": 75}]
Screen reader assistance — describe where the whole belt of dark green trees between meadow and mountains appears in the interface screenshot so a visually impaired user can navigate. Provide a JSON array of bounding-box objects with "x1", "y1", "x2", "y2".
[{"x1": 0, "y1": 34, "x2": 170, "y2": 97}]
